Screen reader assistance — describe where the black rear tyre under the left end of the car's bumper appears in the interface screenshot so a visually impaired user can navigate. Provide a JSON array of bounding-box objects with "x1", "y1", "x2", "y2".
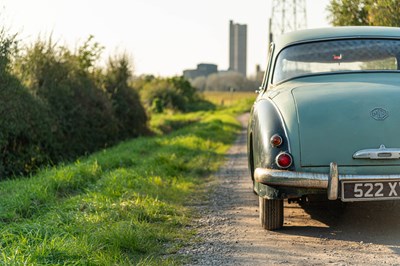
[{"x1": 259, "y1": 197, "x2": 283, "y2": 231}]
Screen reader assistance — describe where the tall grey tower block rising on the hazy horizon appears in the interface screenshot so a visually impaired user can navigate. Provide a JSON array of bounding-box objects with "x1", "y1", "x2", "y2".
[{"x1": 229, "y1": 20, "x2": 247, "y2": 77}]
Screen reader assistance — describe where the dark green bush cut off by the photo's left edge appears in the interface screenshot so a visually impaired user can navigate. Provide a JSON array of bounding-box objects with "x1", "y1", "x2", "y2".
[{"x1": 0, "y1": 31, "x2": 52, "y2": 179}]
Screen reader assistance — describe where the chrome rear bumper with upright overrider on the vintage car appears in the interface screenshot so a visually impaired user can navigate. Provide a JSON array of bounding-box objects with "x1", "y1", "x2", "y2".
[{"x1": 254, "y1": 163, "x2": 400, "y2": 200}]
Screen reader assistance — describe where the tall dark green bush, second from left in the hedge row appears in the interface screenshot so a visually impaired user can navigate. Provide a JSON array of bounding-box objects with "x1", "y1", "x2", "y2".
[{"x1": 18, "y1": 38, "x2": 117, "y2": 160}]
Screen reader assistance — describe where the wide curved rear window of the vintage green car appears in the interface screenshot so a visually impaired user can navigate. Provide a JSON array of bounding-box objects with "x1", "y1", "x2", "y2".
[{"x1": 272, "y1": 39, "x2": 400, "y2": 83}]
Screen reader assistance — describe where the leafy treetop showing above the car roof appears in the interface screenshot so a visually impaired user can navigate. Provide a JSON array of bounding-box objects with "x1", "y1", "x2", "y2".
[{"x1": 327, "y1": 0, "x2": 400, "y2": 27}]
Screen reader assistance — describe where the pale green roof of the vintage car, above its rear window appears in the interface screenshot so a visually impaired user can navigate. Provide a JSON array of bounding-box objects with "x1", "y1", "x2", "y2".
[{"x1": 274, "y1": 26, "x2": 400, "y2": 51}]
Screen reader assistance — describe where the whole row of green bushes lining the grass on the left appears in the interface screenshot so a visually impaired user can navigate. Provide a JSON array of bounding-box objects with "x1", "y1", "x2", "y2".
[{"x1": 0, "y1": 30, "x2": 197, "y2": 179}]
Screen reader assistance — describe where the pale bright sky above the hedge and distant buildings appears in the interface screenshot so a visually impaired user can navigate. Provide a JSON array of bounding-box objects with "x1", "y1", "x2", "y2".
[{"x1": 0, "y1": 0, "x2": 329, "y2": 76}]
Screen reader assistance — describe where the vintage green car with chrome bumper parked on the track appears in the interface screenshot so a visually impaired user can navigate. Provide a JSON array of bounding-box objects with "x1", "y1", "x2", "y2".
[{"x1": 248, "y1": 27, "x2": 400, "y2": 230}]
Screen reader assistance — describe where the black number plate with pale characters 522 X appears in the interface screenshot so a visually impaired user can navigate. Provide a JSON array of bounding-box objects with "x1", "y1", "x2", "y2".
[{"x1": 341, "y1": 180, "x2": 400, "y2": 201}]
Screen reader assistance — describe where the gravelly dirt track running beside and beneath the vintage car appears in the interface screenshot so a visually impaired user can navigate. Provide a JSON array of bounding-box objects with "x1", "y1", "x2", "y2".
[{"x1": 181, "y1": 113, "x2": 400, "y2": 265}]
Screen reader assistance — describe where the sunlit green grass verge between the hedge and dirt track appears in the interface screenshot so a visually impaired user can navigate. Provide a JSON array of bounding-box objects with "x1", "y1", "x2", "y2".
[{"x1": 0, "y1": 102, "x2": 248, "y2": 265}]
